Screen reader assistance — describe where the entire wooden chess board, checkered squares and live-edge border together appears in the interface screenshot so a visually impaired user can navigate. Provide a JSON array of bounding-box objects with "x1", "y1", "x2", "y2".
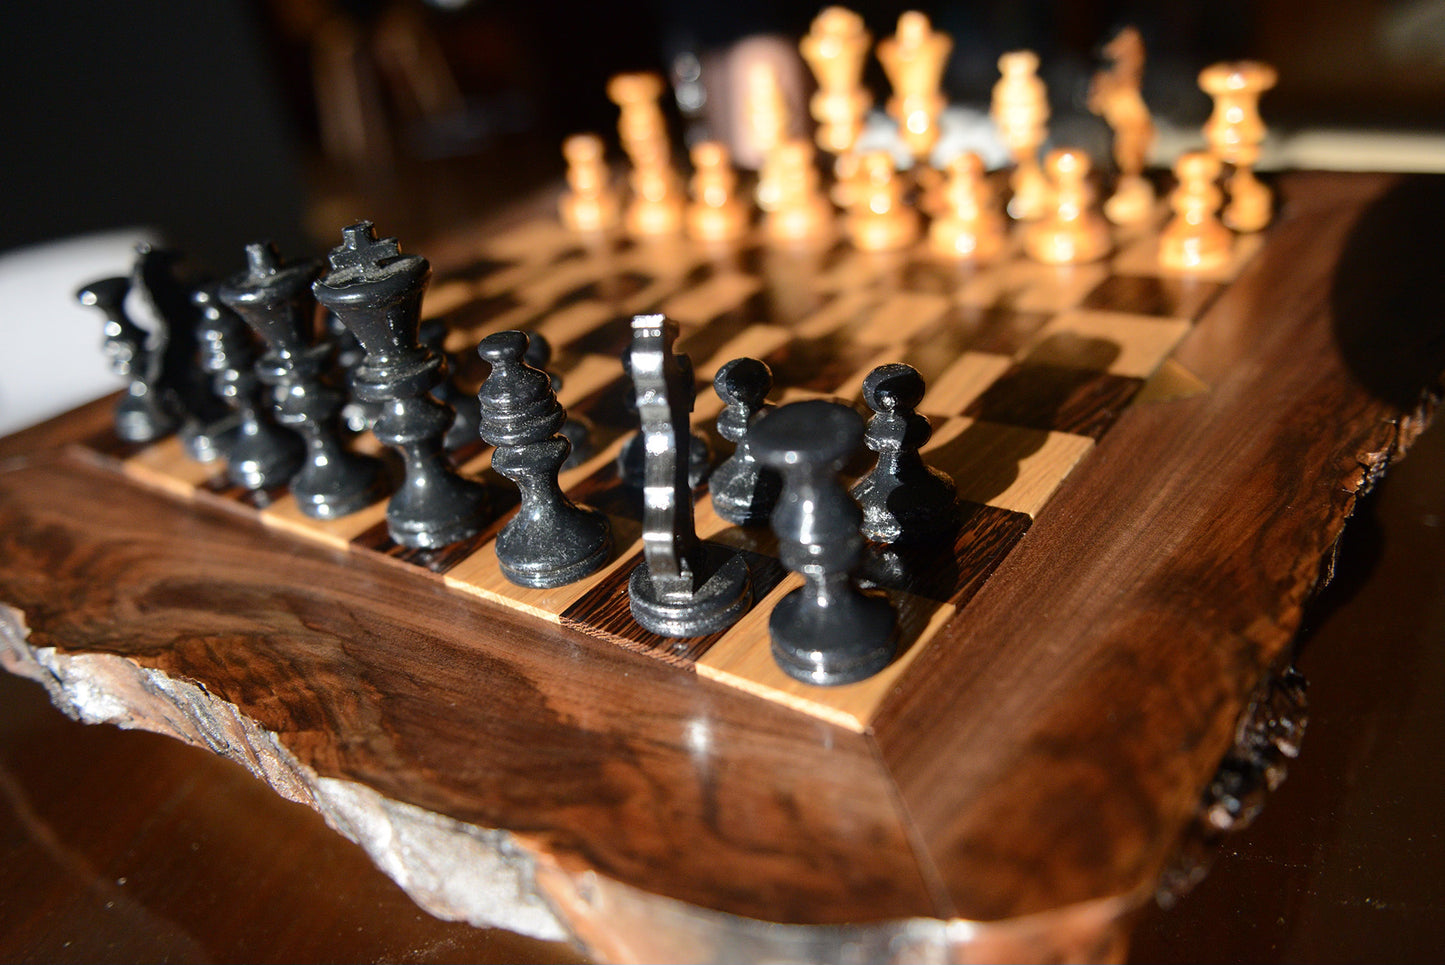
[{"x1": 0, "y1": 175, "x2": 1425, "y2": 958}]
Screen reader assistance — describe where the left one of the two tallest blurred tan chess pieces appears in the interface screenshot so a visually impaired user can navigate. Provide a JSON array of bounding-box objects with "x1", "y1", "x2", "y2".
[{"x1": 798, "y1": 7, "x2": 873, "y2": 155}]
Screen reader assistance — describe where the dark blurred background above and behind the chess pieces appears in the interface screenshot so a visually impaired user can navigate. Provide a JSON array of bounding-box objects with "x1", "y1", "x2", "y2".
[{"x1": 0, "y1": 0, "x2": 1445, "y2": 272}]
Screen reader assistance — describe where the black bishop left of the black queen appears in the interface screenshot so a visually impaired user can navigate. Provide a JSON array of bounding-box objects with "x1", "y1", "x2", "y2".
[{"x1": 191, "y1": 286, "x2": 306, "y2": 491}]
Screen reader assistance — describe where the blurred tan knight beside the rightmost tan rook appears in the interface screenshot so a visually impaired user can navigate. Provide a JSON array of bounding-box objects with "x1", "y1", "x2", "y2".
[{"x1": 1088, "y1": 27, "x2": 1155, "y2": 224}]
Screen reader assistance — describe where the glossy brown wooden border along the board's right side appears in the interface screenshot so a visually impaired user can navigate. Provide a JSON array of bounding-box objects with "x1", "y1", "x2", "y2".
[{"x1": 877, "y1": 175, "x2": 1445, "y2": 919}]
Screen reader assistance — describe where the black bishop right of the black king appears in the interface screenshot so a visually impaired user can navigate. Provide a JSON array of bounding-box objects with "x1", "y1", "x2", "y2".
[{"x1": 477, "y1": 332, "x2": 613, "y2": 587}]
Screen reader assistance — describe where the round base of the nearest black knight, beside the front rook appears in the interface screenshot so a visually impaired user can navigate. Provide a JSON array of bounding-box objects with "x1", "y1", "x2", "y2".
[{"x1": 627, "y1": 543, "x2": 753, "y2": 637}]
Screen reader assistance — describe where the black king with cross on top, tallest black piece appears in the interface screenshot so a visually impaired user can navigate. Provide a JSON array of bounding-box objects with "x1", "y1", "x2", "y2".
[{"x1": 312, "y1": 221, "x2": 491, "y2": 549}]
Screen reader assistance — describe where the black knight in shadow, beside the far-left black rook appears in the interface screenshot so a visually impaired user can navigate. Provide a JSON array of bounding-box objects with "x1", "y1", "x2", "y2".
[{"x1": 130, "y1": 244, "x2": 240, "y2": 462}]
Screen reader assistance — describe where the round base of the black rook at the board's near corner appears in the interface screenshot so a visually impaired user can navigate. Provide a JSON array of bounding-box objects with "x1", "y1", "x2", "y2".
[{"x1": 767, "y1": 587, "x2": 897, "y2": 686}]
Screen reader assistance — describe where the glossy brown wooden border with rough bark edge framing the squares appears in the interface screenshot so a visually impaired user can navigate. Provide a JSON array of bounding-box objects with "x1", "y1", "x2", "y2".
[{"x1": 0, "y1": 175, "x2": 1445, "y2": 961}]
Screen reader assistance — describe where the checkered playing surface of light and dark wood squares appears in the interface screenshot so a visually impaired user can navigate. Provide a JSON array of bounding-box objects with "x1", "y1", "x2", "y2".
[{"x1": 79, "y1": 205, "x2": 1263, "y2": 731}]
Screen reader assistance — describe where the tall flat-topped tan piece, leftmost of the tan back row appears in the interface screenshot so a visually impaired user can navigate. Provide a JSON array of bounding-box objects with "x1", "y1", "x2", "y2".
[{"x1": 607, "y1": 74, "x2": 686, "y2": 237}]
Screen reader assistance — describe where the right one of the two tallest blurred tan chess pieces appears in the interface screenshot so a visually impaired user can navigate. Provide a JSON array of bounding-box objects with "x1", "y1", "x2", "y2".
[{"x1": 879, "y1": 10, "x2": 954, "y2": 163}]
